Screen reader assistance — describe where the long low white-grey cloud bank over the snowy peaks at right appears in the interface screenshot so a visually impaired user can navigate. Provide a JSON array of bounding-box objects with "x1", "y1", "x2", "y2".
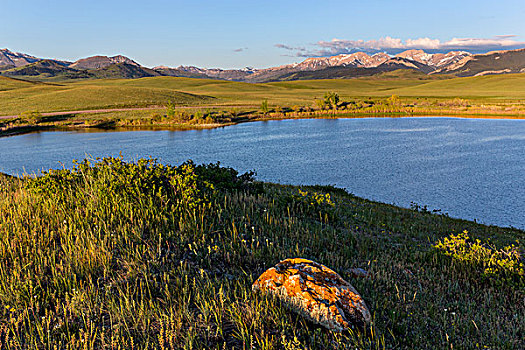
[{"x1": 275, "y1": 35, "x2": 525, "y2": 57}]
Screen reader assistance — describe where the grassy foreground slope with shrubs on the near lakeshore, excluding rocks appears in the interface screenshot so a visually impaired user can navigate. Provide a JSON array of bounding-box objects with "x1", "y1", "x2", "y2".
[{"x1": 0, "y1": 158, "x2": 525, "y2": 349}]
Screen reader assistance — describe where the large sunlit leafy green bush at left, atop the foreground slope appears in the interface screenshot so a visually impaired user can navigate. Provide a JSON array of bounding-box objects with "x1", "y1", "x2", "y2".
[{"x1": 25, "y1": 157, "x2": 209, "y2": 213}]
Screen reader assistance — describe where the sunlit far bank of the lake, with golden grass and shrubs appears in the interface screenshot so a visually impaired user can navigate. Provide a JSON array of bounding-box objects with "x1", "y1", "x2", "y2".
[{"x1": 0, "y1": 100, "x2": 525, "y2": 137}]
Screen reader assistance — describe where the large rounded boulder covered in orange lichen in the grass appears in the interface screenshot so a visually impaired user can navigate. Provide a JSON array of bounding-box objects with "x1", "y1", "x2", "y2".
[{"x1": 252, "y1": 258, "x2": 370, "y2": 332}]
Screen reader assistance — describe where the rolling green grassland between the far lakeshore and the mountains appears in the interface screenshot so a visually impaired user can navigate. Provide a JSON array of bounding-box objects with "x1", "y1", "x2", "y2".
[{"x1": 0, "y1": 72, "x2": 525, "y2": 115}]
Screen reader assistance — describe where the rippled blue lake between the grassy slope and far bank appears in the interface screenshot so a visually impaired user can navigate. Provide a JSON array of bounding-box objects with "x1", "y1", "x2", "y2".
[{"x1": 0, "y1": 118, "x2": 525, "y2": 229}]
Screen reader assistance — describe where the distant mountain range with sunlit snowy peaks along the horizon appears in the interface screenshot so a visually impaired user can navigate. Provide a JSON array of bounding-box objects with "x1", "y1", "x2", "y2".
[{"x1": 0, "y1": 49, "x2": 525, "y2": 83}]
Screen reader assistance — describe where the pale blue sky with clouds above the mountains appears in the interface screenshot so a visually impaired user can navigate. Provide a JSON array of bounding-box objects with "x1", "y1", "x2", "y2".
[{"x1": 0, "y1": 0, "x2": 525, "y2": 68}]
